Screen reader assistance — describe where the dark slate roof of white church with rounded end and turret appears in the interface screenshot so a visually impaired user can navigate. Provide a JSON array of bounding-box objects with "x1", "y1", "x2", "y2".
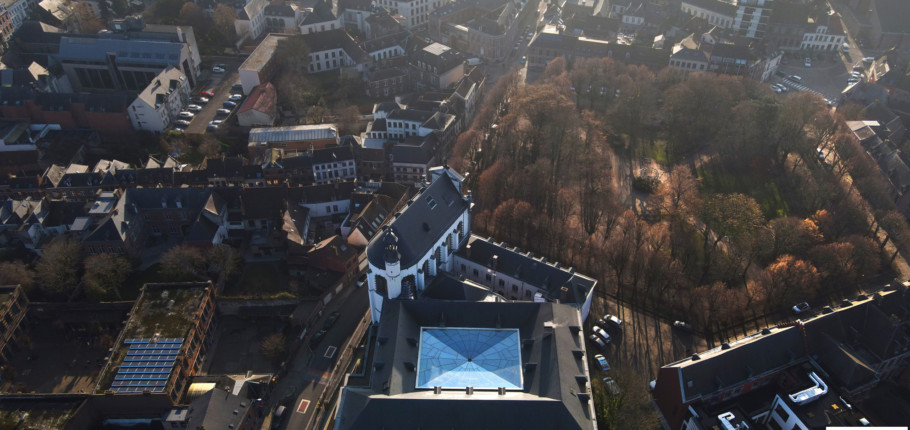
[{"x1": 367, "y1": 172, "x2": 470, "y2": 269}]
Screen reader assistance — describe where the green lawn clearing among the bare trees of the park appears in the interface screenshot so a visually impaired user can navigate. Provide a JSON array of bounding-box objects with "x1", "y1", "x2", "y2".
[{"x1": 696, "y1": 163, "x2": 790, "y2": 219}]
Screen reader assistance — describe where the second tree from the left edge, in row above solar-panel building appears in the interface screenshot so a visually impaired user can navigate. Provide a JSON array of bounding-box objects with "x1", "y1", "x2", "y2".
[{"x1": 35, "y1": 236, "x2": 80, "y2": 294}]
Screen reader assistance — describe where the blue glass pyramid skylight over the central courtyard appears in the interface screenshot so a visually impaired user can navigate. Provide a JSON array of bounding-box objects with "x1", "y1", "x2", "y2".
[{"x1": 417, "y1": 327, "x2": 522, "y2": 390}]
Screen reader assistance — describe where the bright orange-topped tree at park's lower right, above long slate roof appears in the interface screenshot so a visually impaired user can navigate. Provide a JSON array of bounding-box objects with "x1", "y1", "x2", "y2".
[{"x1": 757, "y1": 255, "x2": 819, "y2": 312}]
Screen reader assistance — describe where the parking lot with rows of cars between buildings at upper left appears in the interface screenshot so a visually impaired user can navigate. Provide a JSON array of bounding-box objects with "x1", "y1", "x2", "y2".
[{"x1": 184, "y1": 57, "x2": 244, "y2": 134}]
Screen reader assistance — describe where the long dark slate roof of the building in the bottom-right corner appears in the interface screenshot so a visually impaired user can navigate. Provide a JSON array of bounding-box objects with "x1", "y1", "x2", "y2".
[{"x1": 655, "y1": 291, "x2": 910, "y2": 403}]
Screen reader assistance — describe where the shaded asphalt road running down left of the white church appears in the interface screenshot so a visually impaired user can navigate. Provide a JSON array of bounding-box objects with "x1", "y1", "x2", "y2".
[{"x1": 273, "y1": 281, "x2": 369, "y2": 430}]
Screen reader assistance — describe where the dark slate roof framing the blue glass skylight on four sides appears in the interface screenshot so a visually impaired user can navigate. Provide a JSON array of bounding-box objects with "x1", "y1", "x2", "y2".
[{"x1": 336, "y1": 300, "x2": 594, "y2": 430}]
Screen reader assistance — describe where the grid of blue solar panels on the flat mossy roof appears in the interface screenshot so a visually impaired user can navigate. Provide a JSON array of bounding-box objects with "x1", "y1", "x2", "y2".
[{"x1": 111, "y1": 337, "x2": 183, "y2": 393}]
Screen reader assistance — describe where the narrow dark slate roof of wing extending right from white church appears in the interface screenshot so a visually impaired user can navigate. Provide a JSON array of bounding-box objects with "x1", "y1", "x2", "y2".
[{"x1": 455, "y1": 234, "x2": 597, "y2": 304}]
